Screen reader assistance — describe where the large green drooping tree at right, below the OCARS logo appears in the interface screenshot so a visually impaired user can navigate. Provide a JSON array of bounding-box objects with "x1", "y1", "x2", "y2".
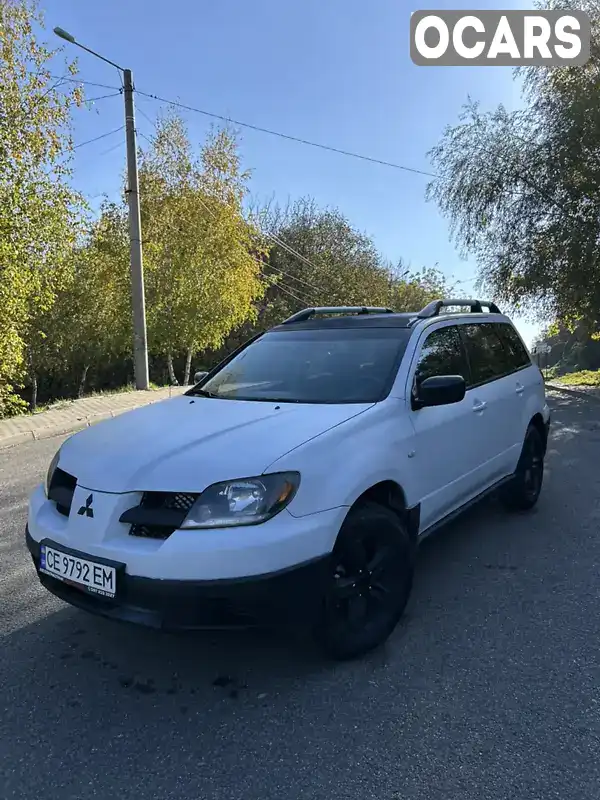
[{"x1": 428, "y1": 0, "x2": 600, "y2": 331}]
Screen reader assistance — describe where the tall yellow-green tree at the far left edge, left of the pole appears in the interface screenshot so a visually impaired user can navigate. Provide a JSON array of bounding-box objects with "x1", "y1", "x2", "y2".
[{"x1": 0, "y1": 0, "x2": 82, "y2": 416}]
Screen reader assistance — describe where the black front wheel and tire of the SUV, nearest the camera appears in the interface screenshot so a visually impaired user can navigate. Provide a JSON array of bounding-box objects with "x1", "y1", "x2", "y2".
[{"x1": 315, "y1": 502, "x2": 414, "y2": 660}]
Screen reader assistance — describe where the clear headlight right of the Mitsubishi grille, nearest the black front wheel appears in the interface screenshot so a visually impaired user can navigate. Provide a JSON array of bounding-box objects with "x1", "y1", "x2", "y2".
[{"x1": 181, "y1": 472, "x2": 300, "y2": 529}]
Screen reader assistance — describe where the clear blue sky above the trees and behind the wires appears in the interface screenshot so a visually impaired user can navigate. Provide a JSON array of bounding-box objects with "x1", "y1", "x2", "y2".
[{"x1": 42, "y1": 0, "x2": 538, "y2": 344}]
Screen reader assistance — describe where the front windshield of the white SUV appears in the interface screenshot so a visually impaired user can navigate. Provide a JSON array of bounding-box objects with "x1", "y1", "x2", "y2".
[{"x1": 191, "y1": 328, "x2": 410, "y2": 403}]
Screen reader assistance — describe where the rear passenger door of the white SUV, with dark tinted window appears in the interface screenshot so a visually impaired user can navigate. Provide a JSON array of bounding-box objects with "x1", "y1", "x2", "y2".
[{"x1": 459, "y1": 321, "x2": 522, "y2": 490}]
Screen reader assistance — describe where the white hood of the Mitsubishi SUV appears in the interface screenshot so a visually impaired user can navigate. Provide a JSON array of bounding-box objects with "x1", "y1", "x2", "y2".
[{"x1": 59, "y1": 395, "x2": 372, "y2": 493}]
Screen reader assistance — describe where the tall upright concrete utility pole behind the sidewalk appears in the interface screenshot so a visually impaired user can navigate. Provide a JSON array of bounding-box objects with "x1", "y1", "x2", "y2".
[{"x1": 123, "y1": 69, "x2": 150, "y2": 389}]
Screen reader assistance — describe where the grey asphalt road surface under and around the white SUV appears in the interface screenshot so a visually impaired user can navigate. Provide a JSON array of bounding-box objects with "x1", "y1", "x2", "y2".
[{"x1": 0, "y1": 390, "x2": 600, "y2": 800}]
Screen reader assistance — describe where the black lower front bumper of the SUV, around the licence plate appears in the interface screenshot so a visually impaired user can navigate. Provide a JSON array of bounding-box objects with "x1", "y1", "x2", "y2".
[{"x1": 25, "y1": 529, "x2": 330, "y2": 630}]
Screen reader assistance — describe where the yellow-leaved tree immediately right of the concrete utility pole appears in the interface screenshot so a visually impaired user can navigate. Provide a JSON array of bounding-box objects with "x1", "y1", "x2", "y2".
[{"x1": 140, "y1": 115, "x2": 264, "y2": 383}]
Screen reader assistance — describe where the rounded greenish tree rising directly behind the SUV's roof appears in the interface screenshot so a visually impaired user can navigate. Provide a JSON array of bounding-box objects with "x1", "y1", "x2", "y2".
[{"x1": 209, "y1": 198, "x2": 446, "y2": 360}]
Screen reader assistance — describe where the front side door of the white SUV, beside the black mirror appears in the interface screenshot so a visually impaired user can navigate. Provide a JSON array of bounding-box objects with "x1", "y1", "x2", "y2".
[{"x1": 406, "y1": 324, "x2": 489, "y2": 530}]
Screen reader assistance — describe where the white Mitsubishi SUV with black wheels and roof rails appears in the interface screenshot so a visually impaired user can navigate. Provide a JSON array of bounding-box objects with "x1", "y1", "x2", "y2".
[{"x1": 27, "y1": 300, "x2": 550, "y2": 658}]
